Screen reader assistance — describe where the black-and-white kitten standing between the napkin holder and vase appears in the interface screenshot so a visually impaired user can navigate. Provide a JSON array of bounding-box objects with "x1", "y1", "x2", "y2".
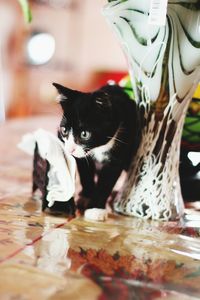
[{"x1": 53, "y1": 83, "x2": 140, "y2": 208}]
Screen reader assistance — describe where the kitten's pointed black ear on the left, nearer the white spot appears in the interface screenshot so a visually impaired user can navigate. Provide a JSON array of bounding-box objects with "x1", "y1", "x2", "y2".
[{"x1": 52, "y1": 82, "x2": 82, "y2": 105}]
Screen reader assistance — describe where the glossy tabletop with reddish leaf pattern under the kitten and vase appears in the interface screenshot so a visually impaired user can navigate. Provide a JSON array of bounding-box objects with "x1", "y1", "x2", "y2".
[{"x1": 0, "y1": 117, "x2": 200, "y2": 300}]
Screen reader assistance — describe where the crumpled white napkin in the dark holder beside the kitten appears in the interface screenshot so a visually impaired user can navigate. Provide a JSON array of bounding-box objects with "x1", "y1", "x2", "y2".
[{"x1": 18, "y1": 129, "x2": 76, "y2": 207}]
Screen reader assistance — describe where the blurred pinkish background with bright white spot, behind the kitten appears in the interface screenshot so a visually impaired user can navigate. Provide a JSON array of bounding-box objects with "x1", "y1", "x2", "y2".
[{"x1": 0, "y1": 0, "x2": 127, "y2": 119}]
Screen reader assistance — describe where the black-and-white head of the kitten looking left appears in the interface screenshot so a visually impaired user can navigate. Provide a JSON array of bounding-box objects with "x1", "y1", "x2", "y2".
[{"x1": 54, "y1": 84, "x2": 119, "y2": 161}]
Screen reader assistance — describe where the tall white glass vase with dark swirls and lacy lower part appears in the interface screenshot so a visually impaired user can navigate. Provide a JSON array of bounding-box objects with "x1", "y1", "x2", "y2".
[{"x1": 103, "y1": 0, "x2": 200, "y2": 220}]
